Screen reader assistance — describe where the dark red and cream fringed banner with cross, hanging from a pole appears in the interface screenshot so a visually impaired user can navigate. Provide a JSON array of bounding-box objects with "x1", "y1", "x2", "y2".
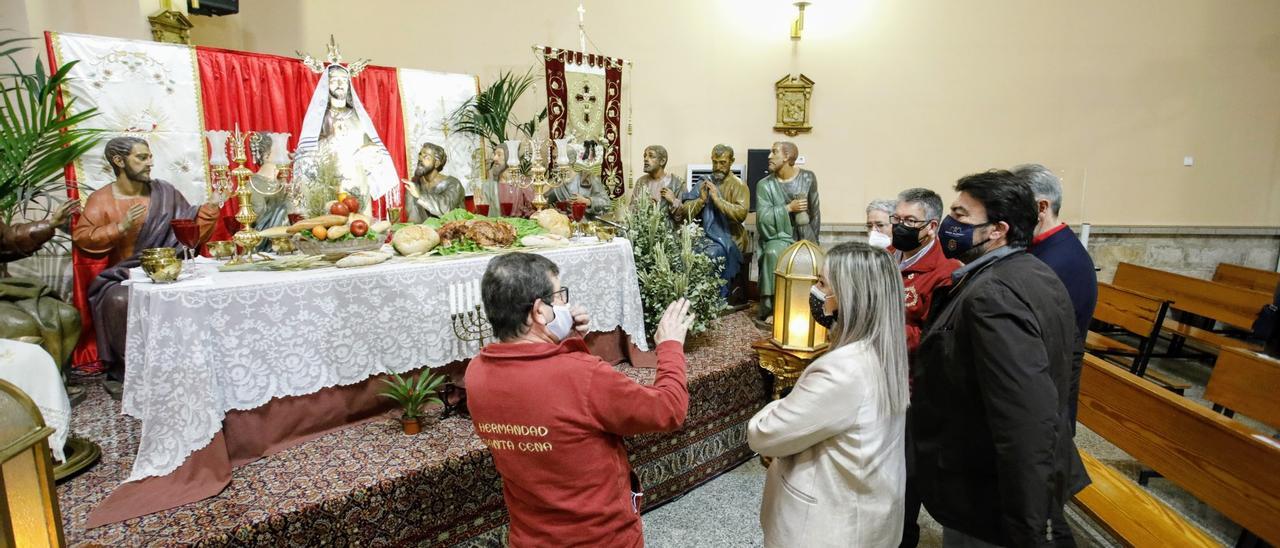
[{"x1": 543, "y1": 47, "x2": 626, "y2": 196}]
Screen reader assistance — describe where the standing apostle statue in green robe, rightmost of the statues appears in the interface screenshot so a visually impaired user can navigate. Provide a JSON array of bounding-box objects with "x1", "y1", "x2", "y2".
[{"x1": 755, "y1": 141, "x2": 822, "y2": 321}]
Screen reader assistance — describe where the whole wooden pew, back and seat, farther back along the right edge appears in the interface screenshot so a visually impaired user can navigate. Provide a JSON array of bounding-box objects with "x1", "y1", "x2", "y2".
[{"x1": 1111, "y1": 262, "x2": 1272, "y2": 351}]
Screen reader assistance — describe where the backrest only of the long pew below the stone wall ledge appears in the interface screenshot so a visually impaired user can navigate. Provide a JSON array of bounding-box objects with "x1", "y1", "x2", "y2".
[{"x1": 1111, "y1": 262, "x2": 1272, "y2": 329}]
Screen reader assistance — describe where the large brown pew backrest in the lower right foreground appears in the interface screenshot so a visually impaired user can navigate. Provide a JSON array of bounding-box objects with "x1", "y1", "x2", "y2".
[{"x1": 1079, "y1": 355, "x2": 1280, "y2": 544}]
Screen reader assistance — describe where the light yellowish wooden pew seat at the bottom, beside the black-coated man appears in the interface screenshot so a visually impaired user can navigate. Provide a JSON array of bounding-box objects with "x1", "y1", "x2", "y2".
[{"x1": 1075, "y1": 451, "x2": 1221, "y2": 547}]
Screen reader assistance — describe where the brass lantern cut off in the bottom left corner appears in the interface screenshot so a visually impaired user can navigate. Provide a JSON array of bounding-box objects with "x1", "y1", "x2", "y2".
[{"x1": 0, "y1": 380, "x2": 64, "y2": 547}]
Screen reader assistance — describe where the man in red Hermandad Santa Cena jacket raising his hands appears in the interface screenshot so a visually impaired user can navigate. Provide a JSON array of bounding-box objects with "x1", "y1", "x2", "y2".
[{"x1": 466, "y1": 254, "x2": 694, "y2": 547}]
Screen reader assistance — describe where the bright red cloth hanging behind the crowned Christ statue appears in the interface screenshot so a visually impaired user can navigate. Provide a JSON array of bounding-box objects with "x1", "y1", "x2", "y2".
[{"x1": 61, "y1": 40, "x2": 407, "y2": 367}]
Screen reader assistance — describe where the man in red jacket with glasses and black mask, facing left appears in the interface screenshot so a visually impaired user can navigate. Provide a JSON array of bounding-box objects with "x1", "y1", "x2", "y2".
[{"x1": 888, "y1": 188, "x2": 960, "y2": 548}]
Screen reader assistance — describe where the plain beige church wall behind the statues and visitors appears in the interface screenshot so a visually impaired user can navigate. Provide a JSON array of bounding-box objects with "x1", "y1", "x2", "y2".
[{"x1": 15, "y1": 0, "x2": 1280, "y2": 225}]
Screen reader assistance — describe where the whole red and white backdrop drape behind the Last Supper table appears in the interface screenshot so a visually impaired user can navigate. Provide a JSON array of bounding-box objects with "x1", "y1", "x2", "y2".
[{"x1": 45, "y1": 32, "x2": 483, "y2": 367}]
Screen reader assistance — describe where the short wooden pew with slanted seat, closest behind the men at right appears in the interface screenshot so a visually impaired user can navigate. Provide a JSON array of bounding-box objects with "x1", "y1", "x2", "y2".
[{"x1": 1084, "y1": 282, "x2": 1192, "y2": 394}]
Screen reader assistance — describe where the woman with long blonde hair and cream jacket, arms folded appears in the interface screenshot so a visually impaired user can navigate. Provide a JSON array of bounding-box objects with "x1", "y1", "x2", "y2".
[{"x1": 748, "y1": 242, "x2": 910, "y2": 547}]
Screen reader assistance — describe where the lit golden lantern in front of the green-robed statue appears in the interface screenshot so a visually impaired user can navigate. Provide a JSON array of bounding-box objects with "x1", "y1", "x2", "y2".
[{"x1": 772, "y1": 239, "x2": 827, "y2": 352}]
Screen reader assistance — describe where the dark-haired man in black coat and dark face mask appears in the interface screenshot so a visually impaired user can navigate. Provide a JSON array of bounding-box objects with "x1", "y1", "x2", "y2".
[{"x1": 909, "y1": 170, "x2": 1087, "y2": 547}]
